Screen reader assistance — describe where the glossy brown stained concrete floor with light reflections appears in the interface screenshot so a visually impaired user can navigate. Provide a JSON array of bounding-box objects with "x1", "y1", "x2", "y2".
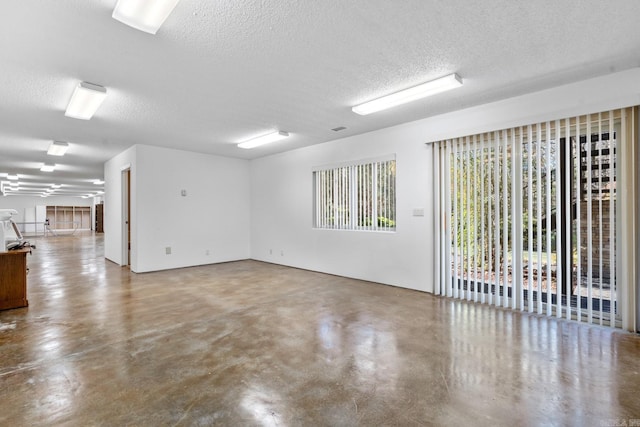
[{"x1": 0, "y1": 235, "x2": 640, "y2": 426}]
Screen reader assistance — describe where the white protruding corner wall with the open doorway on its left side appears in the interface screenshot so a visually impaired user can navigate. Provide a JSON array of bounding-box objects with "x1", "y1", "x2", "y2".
[{"x1": 105, "y1": 145, "x2": 250, "y2": 273}]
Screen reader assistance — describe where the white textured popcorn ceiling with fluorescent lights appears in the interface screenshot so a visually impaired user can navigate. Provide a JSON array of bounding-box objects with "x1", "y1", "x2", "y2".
[{"x1": 0, "y1": 0, "x2": 640, "y2": 195}]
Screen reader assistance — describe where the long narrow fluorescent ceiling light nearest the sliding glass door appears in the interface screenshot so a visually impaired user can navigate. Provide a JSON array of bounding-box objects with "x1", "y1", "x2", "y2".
[{"x1": 351, "y1": 74, "x2": 462, "y2": 116}]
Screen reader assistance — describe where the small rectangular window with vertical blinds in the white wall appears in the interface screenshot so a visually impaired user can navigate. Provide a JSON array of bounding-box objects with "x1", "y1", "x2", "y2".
[{"x1": 313, "y1": 156, "x2": 396, "y2": 231}]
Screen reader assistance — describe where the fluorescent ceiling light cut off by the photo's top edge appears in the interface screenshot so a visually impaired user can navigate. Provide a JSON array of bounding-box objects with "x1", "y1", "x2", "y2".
[{"x1": 111, "y1": 0, "x2": 180, "y2": 34}]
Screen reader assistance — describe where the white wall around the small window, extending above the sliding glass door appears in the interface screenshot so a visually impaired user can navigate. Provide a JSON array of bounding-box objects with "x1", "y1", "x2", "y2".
[{"x1": 251, "y1": 68, "x2": 640, "y2": 292}]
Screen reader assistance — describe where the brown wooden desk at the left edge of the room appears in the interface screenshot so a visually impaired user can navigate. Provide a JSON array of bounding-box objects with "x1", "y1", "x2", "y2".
[{"x1": 0, "y1": 248, "x2": 31, "y2": 310}]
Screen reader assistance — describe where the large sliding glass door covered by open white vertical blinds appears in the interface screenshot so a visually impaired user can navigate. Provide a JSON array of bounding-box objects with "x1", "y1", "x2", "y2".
[{"x1": 433, "y1": 109, "x2": 635, "y2": 327}]
